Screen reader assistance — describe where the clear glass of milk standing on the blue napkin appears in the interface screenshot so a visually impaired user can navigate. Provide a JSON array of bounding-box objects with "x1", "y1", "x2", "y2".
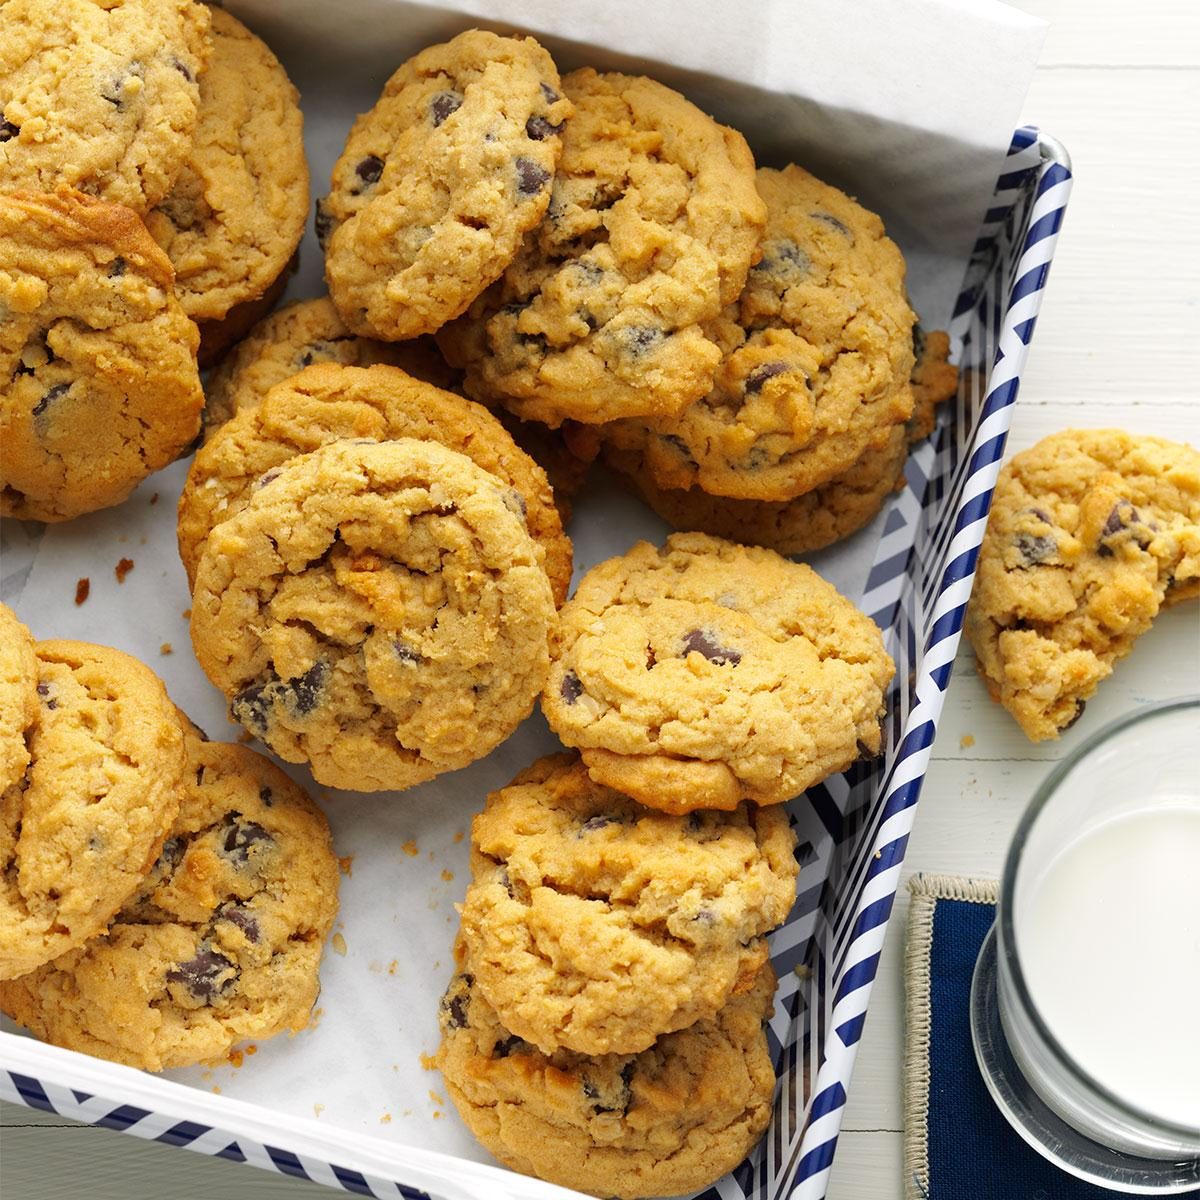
[{"x1": 972, "y1": 697, "x2": 1200, "y2": 1194}]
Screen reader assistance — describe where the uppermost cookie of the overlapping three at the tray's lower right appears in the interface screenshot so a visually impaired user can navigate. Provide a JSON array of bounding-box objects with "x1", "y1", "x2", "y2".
[{"x1": 542, "y1": 533, "x2": 893, "y2": 812}]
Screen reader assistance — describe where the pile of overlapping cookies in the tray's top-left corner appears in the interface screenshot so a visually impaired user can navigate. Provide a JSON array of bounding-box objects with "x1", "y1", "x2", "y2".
[{"x1": 0, "y1": 0, "x2": 308, "y2": 521}]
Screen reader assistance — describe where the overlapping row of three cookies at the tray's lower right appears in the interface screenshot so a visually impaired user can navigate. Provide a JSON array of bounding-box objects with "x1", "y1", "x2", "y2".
[{"x1": 437, "y1": 534, "x2": 893, "y2": 1198}]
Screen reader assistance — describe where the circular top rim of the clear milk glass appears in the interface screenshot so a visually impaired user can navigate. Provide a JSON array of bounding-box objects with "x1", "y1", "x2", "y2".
[{"x1": 996, "y1": 695, "x2": 1200, "y2": 1141}]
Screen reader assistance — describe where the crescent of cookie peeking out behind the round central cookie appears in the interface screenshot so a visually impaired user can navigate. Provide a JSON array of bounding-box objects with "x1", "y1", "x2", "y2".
[{"x1": 179, "y1": 362, "x2": 571, "y2": 604}]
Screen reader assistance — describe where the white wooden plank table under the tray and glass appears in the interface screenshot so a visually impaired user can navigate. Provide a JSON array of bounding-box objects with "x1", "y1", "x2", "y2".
[{"x1": 0, "y1": 0, "x2": 1200, "y2": 1200}]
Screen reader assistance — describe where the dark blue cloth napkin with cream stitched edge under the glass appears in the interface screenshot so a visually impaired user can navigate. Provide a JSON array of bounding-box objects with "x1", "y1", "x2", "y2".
[{"x1": 906, "y1": 877, "x2": 1180, "y2": 1200}]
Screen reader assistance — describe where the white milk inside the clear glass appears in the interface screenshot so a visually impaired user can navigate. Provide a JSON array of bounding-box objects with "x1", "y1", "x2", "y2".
[{"x1": 1015, "y1": 799, "x2": 1200, "y2": 1129}]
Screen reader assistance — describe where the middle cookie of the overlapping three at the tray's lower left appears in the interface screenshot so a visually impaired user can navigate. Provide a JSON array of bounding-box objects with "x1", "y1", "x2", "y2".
[{"x1": 0, "y1": 642, "x2": 184, "y2": 979}]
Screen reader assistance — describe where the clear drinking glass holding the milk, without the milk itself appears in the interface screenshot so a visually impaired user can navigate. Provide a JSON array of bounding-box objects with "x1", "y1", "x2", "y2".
[{"x1": 972, "y1": 697, "x2": 1200, "y2": 1194}]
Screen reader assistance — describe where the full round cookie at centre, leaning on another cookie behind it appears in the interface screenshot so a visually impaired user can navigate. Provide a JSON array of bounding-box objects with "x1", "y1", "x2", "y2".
[{"x1": 192, "y1": 436, "x2": 554, "y2": 792}]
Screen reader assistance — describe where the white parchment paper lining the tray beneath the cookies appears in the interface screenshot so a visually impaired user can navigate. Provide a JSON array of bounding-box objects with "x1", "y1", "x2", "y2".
[{"x1": 4, "y1": 0, "x2": 1043, "y2": 1180}]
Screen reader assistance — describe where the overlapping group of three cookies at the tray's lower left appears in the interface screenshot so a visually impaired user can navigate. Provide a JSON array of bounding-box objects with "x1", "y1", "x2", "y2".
[{"x1": 0, "y1": 605, "x2": 338, "y2": 1070}]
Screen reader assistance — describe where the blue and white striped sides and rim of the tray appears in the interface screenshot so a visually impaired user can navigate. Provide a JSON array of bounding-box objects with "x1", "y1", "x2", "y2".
[{"x1": 0, "y1": 127, "x2": 1072, "y2": 1200}]
